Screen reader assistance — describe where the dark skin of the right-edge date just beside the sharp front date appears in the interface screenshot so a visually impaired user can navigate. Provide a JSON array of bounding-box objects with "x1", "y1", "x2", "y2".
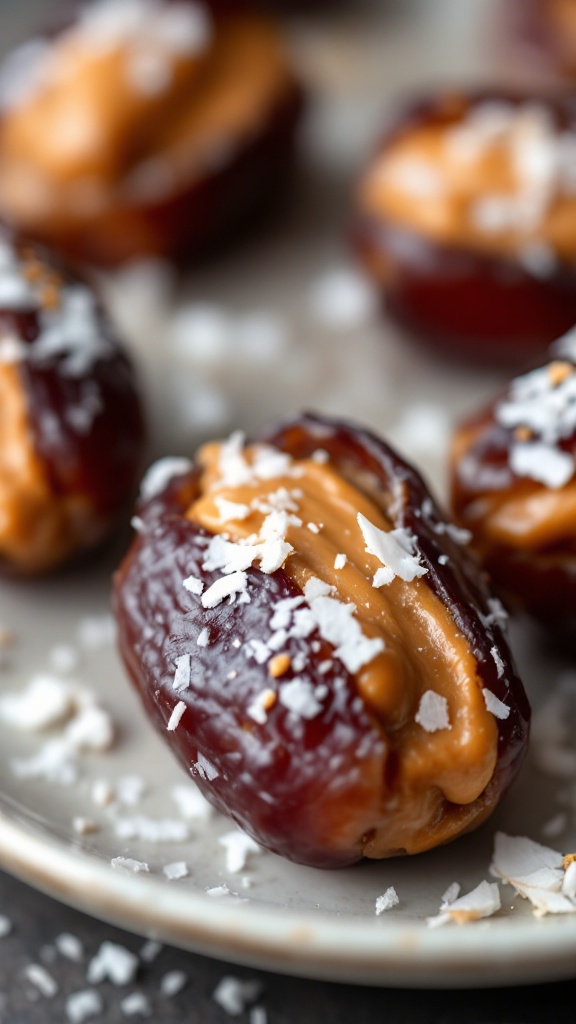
[{"x1": 451, "y1": 380, "x2": 576, "y2": 649}]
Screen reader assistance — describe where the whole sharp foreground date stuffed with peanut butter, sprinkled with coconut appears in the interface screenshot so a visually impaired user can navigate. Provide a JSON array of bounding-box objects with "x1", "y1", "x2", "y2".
[{"x1": 114, "y1": 416, "x2": 529, "y2": 867}]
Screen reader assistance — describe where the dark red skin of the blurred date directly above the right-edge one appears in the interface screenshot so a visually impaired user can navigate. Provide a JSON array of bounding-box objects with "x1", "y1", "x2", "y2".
[{"x1": 352, "y1": 91, "x2": 576, "y2": 367}]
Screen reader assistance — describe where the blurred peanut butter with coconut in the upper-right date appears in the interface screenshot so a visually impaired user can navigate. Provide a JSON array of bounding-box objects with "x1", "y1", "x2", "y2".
[{"x1": 359, "y1": 101, "x2": 576, "y2": 262}]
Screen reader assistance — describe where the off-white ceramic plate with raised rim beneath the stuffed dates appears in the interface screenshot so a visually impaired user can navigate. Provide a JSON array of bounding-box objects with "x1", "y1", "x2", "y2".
[{"x1": 0, "y1": 0, "x2": 576, "y2": 986}]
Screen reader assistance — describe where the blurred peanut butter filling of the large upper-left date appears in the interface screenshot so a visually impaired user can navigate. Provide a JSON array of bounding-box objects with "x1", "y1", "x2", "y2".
[{"x1": 0, "y1": 15, "x2": 292, "y2": 226}]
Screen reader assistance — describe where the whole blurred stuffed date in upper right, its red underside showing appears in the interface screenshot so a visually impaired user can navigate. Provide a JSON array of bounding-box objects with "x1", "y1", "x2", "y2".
[{"x1": 353, "y1": 93, "x2": 576, "y2": 367}]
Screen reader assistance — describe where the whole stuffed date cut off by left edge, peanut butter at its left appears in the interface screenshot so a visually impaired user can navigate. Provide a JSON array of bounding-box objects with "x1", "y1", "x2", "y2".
[{"x1": 0, "y1": 228, "x2": 145, "y2": 573}]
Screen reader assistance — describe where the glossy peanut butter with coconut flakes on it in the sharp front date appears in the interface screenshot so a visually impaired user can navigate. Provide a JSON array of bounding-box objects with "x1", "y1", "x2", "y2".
[{"x1": 187, "y1": 438, "x2": 497, "y2": 856}]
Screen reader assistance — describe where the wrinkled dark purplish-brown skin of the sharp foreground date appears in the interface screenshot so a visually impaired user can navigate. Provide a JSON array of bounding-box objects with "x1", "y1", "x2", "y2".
[{"x1": 113, "y1": 416, "x2": 530, "y2": 868}]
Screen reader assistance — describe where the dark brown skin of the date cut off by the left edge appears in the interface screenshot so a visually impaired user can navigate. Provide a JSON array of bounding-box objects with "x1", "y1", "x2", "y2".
[{"x1": 0, "y1": 229, "x2": 147, "y2": 567}]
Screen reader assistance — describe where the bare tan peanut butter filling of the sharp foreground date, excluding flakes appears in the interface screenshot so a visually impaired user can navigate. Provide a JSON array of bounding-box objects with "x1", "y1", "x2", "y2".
[{"x1": 187, "y1": 444, "x2": 498, "y2": 856}]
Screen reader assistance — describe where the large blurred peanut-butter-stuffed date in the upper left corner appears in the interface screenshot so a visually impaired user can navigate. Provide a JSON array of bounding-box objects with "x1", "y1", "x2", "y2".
[{"x1": 0, "y1": 0, "x2": 302, "y2": 266}]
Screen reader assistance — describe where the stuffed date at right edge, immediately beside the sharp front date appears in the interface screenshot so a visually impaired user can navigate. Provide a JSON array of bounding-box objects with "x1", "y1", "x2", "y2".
[{"x1": 451, "y1": 332, "x2": 576, "y2": 646}]
